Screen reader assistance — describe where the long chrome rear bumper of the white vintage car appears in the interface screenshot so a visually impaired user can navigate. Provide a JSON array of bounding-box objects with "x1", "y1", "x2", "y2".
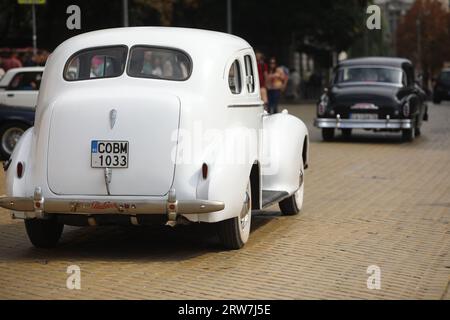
[{"x1": 0, "y1": 188, "x2": 225, "y2": 220}]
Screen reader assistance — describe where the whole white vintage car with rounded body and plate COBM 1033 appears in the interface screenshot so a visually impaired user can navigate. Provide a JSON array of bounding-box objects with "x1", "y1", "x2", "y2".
[{"x1": 0, "y1": 27, "x2": 308, "y2": 249}]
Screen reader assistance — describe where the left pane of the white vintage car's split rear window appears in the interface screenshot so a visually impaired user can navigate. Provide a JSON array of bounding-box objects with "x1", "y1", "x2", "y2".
[{"x1": 64, "y1": 46, "x2": 128, "y2": 81}]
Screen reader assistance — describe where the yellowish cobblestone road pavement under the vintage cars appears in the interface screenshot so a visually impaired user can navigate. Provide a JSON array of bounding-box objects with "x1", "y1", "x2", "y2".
[{"x1": 0, "y1": 104, "x2": 450, "y2": 299}]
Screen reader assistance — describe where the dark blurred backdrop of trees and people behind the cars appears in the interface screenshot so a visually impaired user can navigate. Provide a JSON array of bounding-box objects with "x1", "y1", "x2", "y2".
[{"x1": 0, "y1": 0, "x2": 450, "y2": 101}]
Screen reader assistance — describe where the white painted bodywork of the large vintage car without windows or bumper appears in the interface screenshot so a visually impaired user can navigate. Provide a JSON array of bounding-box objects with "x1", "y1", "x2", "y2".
[{"x1": 3, "y1": 27, "x2": 308, "y2": 223}]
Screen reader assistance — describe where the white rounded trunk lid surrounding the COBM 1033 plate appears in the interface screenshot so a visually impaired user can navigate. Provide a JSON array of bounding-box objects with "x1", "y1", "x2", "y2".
[{"x1": 47, "y1": 88, "x2": 181, "y2": 196}]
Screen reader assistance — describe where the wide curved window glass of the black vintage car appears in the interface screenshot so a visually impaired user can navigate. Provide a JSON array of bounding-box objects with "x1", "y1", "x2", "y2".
[{"x1": 335, "y1": 66, "x2": 406, "y2": 85}]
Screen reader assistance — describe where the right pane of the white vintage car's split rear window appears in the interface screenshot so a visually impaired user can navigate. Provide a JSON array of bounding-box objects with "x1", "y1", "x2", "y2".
[{"x1": 127, "y1": 46, "x2": 192, "y2": 81}]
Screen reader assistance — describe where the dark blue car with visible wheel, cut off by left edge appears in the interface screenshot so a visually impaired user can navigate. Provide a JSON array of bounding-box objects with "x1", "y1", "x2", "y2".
[{"x1": 0, "y1": 105, "x2": 35, "y2": 160}]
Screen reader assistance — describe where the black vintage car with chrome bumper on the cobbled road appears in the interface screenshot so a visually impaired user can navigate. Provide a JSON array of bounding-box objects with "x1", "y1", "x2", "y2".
[{"x1": 314, "y1": 57, "x2": 428, "y2": 141}]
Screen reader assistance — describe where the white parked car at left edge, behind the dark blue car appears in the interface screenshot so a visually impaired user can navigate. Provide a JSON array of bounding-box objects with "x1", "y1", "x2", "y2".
[{"x1": 0, "y1": 67, "x2": 44, "y2": 108}]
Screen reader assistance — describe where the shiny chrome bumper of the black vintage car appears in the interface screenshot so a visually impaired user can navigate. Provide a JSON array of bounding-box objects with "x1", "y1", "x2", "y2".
[{"x1": 314, "y1": 116, "x2": 414, "y2": 129}]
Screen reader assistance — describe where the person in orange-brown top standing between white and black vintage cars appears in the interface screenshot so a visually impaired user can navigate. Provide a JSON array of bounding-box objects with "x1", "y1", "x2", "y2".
[{"x1": 265, "y1": 58, "x2": 287, "y2": 114}]
